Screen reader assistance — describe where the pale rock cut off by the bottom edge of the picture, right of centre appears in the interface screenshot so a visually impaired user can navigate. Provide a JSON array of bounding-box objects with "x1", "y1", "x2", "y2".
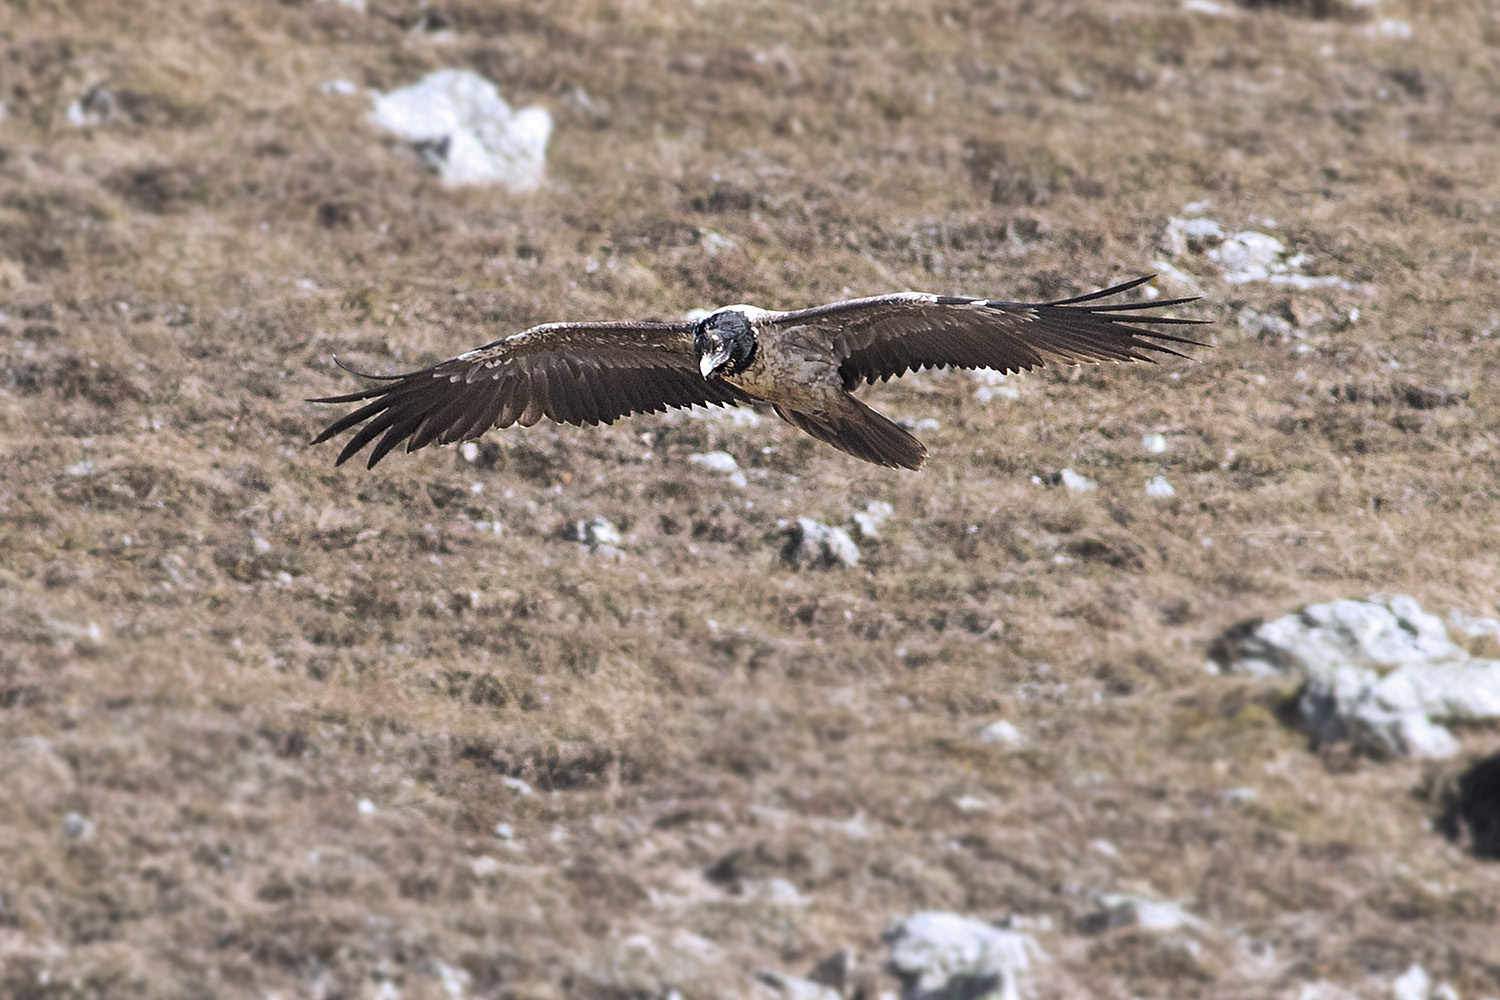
[{"x1": 885, "y1": 912, "x2": 1047, "y2": 1000}]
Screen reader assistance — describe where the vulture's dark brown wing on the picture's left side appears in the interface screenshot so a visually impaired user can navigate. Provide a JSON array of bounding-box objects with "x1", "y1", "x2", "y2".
[{"x1": 311, "y1": 322, "x2": 749, "y2": 468}]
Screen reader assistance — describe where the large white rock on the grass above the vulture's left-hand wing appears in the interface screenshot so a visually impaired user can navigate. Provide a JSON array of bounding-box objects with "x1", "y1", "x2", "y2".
[{"x1": 371, "y1": 69, "x2": 552, "y2": 193}]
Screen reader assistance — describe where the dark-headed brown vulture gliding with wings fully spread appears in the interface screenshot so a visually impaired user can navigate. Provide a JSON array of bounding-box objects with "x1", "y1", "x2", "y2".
[{"x1": 312, "y1": 276, "x2": 1206, "y2": 469}]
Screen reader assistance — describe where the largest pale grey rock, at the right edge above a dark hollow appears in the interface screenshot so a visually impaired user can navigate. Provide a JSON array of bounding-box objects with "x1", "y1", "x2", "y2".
[{"x1": 1212, "y1": 594, "x2": 1500, "y2": 759}]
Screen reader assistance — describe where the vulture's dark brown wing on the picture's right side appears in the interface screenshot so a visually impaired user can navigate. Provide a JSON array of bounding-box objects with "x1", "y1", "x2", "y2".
[{"x1": 774, "y1": 274, "x2": 1206, "y2": 388}]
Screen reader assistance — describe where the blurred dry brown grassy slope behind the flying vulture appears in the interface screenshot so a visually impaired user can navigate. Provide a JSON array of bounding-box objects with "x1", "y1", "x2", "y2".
[{"x1": 0, "y1": 0, "x2": 1500, "y2": 1000}]
